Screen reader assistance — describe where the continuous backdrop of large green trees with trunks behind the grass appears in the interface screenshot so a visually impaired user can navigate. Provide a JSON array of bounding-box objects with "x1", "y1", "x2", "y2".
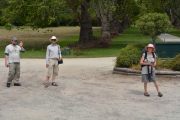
[{"x1": 0, "y1": 0, "x2": 180, "y2": 46}]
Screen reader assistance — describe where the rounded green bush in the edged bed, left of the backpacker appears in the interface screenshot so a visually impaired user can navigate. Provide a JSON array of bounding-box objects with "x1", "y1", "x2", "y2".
[{"x1": 116, "y1": 45, "x2": 141, "y2": 68}]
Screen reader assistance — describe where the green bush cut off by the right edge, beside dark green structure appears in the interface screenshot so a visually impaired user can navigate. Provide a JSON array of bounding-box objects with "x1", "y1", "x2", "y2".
[{"x1": 172, "y1": 54, "x2": 180, "y2": 71}]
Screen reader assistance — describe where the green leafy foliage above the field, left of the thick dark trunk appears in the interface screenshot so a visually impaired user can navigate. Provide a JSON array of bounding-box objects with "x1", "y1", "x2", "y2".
[{"x1": 0, "y1": 0, "x2": 77, "y2": 28}]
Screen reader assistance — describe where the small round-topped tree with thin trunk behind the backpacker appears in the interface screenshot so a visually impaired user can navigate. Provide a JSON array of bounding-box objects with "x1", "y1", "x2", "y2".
[{"x1": 136, "y1": 13, "x2": 170, "y2": 43}]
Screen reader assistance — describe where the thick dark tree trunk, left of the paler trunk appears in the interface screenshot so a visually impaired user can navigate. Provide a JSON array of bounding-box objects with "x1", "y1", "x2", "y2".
[{"x1": 79, "y1": 0, "x2": 93, "y2": 44}]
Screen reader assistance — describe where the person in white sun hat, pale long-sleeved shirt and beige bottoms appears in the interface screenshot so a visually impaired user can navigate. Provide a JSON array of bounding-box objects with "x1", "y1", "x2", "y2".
[{"x1": 44, "y1": 36, "x2": 62, "y2": 87}]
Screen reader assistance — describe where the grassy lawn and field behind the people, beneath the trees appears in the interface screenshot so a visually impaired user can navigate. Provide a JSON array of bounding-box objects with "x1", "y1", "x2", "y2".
[{"x1": 0, "y1": 27, "x2": 156, "y2": 58}]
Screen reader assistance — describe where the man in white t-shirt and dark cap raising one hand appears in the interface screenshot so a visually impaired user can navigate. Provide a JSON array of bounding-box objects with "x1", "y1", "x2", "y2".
[{"x1": 5, "y1": 37, "x2": 25, "y2": 87}]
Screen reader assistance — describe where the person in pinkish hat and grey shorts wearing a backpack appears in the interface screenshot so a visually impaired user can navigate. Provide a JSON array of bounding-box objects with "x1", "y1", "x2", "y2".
[{"x1": 140, "y1": 44, "x2": 163, "y2": 97}]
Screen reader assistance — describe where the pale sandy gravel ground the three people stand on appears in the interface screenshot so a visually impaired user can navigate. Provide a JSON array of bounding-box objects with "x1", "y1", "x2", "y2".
[{"x1": 0, "y1": 58, "x2": 180, "y2": 120}]
